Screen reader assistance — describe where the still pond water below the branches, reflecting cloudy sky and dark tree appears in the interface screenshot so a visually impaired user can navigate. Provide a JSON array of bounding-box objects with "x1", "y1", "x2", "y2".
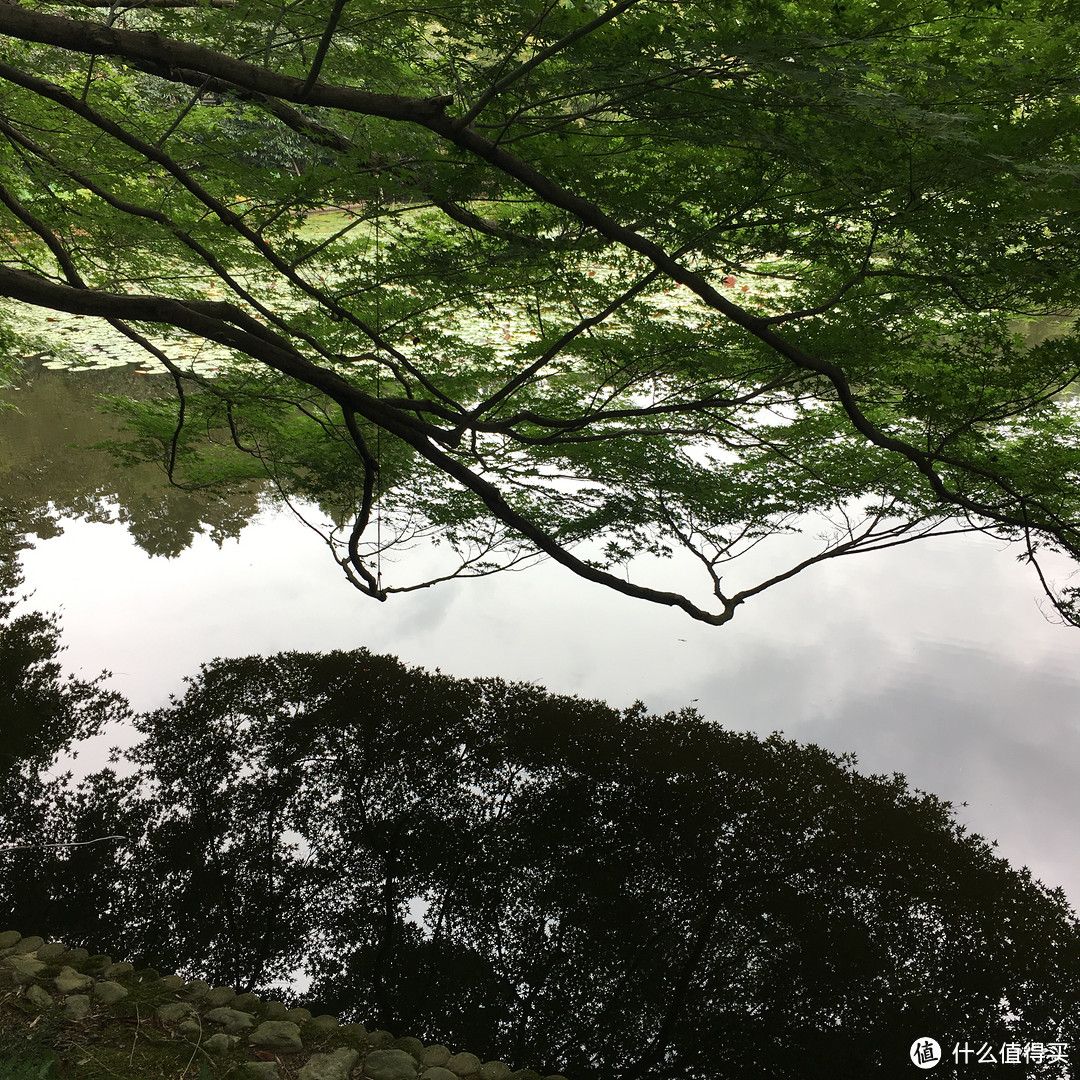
[{"x1": 0, "y1": 356, "x2": 1080, "y2": 1080}]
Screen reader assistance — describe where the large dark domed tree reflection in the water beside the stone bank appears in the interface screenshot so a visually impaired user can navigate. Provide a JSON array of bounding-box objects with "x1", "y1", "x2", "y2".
[{"x1": 0, "y1": 650, "x2": 1080, "y2": 1080}]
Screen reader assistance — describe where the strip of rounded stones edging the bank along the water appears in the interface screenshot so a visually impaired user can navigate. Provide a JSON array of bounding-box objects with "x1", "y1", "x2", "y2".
[{"x1": 0, "y1": 930, "x2": 566, "y2": 1080}]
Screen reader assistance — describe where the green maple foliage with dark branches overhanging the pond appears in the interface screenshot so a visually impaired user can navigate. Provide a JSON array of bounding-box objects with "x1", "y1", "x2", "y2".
[{"x1": 0, "y1": 0, "x2": 1080, "y2": 623}]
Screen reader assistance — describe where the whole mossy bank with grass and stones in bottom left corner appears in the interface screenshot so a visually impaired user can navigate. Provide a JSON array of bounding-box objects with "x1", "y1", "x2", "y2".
[{"x1": 0, "y1": 930, "x2": 565, "y2": 1080}]
